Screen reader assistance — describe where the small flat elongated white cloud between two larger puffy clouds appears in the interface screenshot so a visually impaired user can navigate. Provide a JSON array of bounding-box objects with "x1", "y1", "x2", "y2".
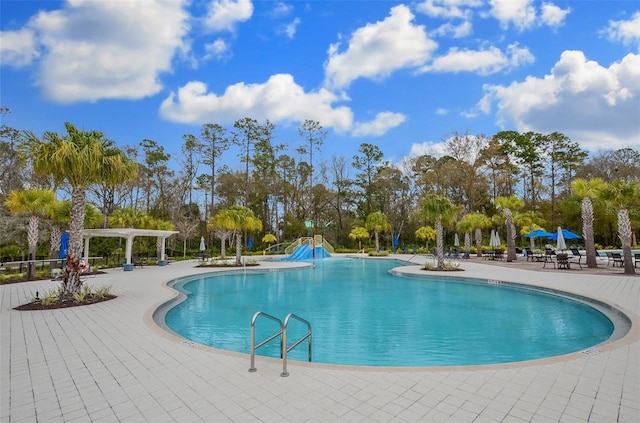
[{"x1": 420, "y1": 44, "x2": 534, "y2": 75}]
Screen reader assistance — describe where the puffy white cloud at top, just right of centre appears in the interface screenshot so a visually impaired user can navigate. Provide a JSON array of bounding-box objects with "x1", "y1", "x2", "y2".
[{"x1": 325, "y1": 5, "x2": 437, "y2": 89}]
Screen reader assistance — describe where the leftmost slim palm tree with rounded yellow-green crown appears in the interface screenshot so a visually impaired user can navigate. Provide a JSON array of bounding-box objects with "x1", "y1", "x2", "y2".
[{"x1": 4, "y1": 189, "x2": 56, "y2": 280}]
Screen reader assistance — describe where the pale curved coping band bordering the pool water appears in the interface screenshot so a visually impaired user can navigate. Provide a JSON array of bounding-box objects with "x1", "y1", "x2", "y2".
[{"x1": 143, "y1": 257, "x2": 640, "y2": 373}]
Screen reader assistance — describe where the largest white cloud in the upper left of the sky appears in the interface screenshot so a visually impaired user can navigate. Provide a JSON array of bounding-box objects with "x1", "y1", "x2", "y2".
[{"x1": 20, "y1": 0, "x2": 189, "y2": 103}]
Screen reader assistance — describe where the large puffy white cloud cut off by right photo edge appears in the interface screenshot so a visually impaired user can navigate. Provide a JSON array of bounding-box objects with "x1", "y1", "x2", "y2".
[{"x1": 478, "y1": 51, "x2": 640, "y2": 150}]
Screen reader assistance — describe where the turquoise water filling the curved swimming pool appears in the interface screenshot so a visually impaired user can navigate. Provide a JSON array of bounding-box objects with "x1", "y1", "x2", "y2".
[{"x1": 165, "y1": 258, "x2": 614, "y2": 366}]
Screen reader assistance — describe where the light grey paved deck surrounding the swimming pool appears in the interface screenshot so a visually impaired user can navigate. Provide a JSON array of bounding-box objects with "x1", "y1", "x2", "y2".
[{"x1": 0, "y1": 257, "x2": 640, "y2": 423}]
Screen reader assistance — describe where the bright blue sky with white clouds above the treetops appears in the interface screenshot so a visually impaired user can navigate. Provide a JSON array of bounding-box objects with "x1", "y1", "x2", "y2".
[{"x1": 0, "y1": 0, "x2": 640, "y2": 171}]
